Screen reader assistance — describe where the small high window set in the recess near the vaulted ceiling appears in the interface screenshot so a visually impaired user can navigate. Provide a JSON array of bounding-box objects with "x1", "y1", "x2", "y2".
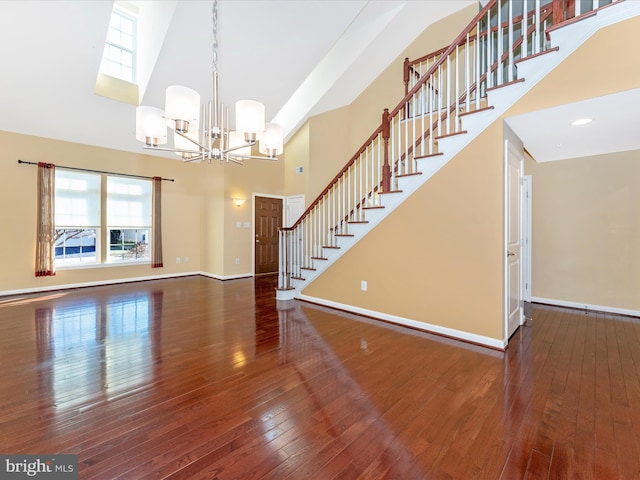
[{"x1": 100, "y1": 7, "x2": 136, "y2": 83}]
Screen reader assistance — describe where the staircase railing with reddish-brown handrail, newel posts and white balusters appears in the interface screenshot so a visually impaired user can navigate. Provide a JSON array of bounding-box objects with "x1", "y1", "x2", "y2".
[{"x1": 278, "y1": 0, "x2": 622, "y2": 290}]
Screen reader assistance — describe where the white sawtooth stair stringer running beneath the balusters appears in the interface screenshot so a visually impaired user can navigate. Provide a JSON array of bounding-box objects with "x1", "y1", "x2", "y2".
[{"x1": 276, "y1": 0, "x2": 640, "y2": 302}]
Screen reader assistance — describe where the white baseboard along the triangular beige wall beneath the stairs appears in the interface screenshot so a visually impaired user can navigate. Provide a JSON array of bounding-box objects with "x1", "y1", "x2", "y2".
[{"x1": 297, "y1": 294, "x2": 507, "y2": 350}]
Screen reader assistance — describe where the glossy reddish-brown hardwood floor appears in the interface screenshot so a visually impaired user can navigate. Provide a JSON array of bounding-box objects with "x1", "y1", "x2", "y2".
[{"x1": 0, "y1": 277, "x2": 640, "y2": 480}]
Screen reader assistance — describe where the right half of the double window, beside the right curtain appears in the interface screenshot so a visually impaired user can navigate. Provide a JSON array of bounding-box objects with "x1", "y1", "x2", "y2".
[{"x1": 107, "y1": 177, "x2": 151, "y2": 262}]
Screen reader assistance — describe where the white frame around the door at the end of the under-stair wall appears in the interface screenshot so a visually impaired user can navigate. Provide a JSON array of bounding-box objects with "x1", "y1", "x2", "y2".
[{"x1": 502, "y1": 139, "x2": 524, "y2": 346}]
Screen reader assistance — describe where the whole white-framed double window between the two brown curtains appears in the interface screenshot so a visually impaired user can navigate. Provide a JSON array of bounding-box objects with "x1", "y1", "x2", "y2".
[{"x1": 54, "y1": 169, "x2": 152, "y2": 267}]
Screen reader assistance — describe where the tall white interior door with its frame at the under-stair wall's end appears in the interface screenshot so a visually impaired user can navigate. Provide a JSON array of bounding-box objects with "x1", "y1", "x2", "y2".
[{"x1": 505, "y1": 140, "x2": 524, "y2": 338}]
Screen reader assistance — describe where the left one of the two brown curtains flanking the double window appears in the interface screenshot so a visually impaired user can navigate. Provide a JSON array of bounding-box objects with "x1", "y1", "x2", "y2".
[{"x1": 36, "y1": 162, "x2": 56, "y2": 277}]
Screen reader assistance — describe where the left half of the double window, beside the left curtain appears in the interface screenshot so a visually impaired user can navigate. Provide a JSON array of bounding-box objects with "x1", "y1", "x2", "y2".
[{"x1": 54, "y1": 169, "x2": 100, "y2": 266}]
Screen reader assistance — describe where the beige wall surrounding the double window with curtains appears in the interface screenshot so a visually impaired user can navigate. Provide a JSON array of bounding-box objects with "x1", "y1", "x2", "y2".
[{"x1": 0, "y1": 131, "x2": 201, "y2": 292}]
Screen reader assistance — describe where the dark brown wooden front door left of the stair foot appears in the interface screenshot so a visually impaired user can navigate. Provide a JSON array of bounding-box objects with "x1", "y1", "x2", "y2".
[{"x1": 255, "y1": 197, "x2": 282, "y2": 275}]
